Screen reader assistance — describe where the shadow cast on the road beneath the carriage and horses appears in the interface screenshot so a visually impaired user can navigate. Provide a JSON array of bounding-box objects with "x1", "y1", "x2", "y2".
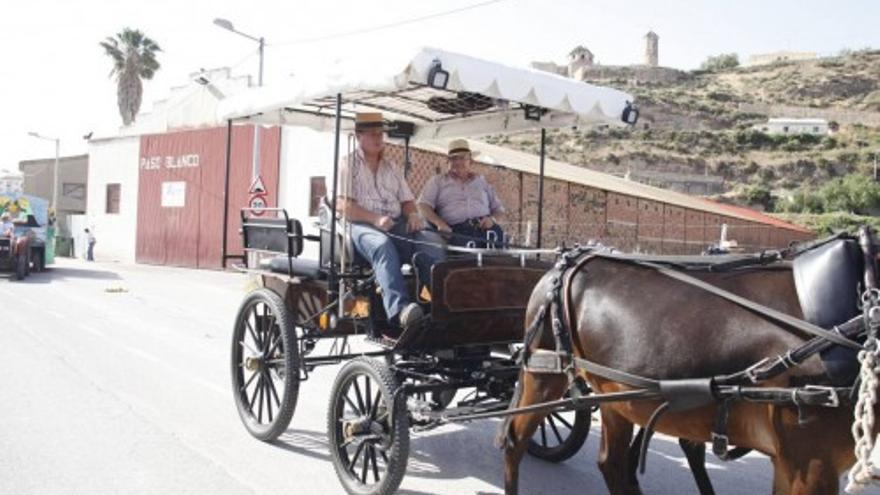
[{"x1": 272, "y1": 421, "x2": 772, "y2": 495}]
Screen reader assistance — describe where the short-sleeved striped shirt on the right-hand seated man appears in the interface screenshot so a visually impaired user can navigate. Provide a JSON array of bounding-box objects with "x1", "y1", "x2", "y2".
[{"x1": 419, "y1": 173, "x2": 504, "y2": 225}]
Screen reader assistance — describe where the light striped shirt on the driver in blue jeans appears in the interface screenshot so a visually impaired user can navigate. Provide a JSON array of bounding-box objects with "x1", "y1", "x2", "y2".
[{"x1": 339, "y1": 149, "x2": 415, "y2": 218}]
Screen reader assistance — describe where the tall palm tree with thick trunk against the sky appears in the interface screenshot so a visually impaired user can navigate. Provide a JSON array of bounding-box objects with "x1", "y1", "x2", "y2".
[{"x1": 100, "y1": 28, "x2": 162, "y2": 125}]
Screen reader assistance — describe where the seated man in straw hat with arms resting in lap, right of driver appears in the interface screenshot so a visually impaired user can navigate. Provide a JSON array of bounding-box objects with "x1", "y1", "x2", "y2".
[{"x1": 419, "y1": 139, "x2": 504, "y2": 247}]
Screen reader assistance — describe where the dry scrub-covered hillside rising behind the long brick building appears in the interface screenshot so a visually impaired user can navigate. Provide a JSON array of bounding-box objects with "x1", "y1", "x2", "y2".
[{"x1": 488, "y1": 50, "x2": 880, "y2": 232}]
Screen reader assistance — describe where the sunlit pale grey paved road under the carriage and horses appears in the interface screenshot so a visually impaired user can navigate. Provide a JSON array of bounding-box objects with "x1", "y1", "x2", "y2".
[{"x1": 0, "y1": 259, "x2": 872, "y2": 495}]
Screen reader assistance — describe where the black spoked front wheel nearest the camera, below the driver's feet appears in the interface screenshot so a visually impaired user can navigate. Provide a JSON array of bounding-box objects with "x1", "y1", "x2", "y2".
[{"x1": 327, "y1": 358, "x2": 409, "y2": 495}]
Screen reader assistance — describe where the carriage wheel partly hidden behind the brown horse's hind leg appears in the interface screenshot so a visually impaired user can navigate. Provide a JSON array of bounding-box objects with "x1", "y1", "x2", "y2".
[{"x1": 528, "y1": 404, "x2": 591, "y2": 462}]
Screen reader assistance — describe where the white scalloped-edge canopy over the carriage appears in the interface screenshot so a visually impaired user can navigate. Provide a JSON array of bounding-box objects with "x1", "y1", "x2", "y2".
[{"x1": 218, "y1": 48, "x2": 636, "y2": 140}]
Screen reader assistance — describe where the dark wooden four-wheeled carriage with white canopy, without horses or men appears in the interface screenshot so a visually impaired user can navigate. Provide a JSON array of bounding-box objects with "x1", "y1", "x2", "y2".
[{"x1": 217, "y1": 50, "x2": 637, "y2": 493}]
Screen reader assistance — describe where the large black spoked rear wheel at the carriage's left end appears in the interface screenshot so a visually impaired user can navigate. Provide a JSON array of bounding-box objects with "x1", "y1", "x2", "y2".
[{"x1": 232, "y1": 289, "x2": 300, "y2": 442}]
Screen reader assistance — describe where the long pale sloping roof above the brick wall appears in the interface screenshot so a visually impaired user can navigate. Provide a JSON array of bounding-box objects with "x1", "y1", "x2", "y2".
[{"x1": 413, "y1": 139, "x2": 811, "y2": 233}]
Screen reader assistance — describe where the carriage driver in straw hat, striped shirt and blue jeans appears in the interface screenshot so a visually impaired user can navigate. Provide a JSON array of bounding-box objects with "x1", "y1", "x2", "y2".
[{"x1": 338, "y1": 113, "x2": 444, "y2": 328}]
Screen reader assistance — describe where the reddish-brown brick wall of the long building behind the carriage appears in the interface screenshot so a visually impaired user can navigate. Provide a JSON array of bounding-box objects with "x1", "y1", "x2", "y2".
[{"x1": 387, "y1": 144, "x2": 810, "y2": 254}]
